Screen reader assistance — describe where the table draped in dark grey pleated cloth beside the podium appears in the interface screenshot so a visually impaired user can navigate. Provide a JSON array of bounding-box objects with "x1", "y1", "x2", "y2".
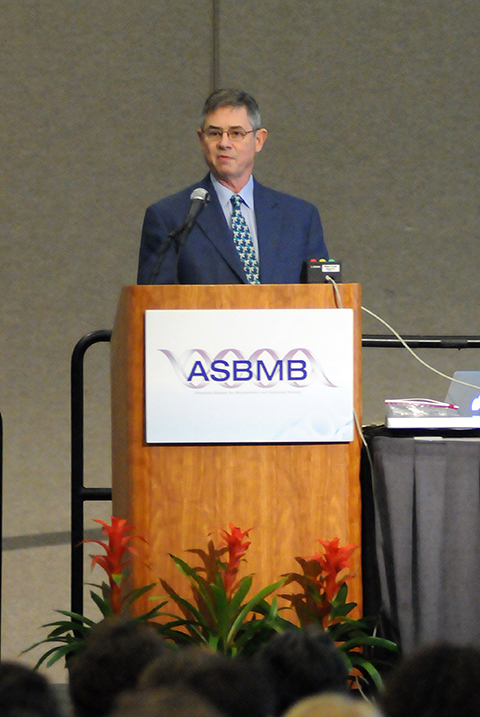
[{"x1": 362, "y1": 428, "x2": 480, "y2": 653}]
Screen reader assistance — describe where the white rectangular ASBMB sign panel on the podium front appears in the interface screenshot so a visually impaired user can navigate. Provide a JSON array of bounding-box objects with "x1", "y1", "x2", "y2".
[{"x1": 145, "y1": 309, "x2": 354, "y2": 443}]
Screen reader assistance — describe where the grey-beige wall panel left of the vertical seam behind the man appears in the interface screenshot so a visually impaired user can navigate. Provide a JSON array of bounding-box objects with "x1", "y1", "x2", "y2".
[{"x1": 0, "y1": 0, "x2": 212, "y2": 679}]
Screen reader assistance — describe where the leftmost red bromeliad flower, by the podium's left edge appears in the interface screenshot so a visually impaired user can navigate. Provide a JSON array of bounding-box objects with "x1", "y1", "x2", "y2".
[{"x1": 82, "y1": 515, "x2": 146, "y2": 615}]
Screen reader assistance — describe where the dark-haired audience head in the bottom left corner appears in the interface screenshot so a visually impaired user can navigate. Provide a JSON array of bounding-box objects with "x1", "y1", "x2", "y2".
[{"x1": 0, "y1": 661, "x2": 60, "y2": 717}]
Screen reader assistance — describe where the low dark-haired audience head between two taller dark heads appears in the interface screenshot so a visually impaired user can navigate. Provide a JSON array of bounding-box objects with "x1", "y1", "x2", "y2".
[{"x1": 139, "y1": 647, "x2": 273, "y2": 717}]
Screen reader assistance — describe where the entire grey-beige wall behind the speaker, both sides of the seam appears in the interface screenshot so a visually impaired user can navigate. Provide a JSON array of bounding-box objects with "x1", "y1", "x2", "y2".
[{"x1": 0, "y1": 0, "x2": 480, "y2": 680}]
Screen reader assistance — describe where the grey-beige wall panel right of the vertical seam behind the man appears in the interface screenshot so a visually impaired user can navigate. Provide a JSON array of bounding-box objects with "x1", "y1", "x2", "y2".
[{"x1": 220, "y1": 0, "x2": 480, "y2": 420}]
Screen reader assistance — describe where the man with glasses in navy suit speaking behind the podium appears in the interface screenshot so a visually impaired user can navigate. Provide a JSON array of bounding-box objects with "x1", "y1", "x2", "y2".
[{"x1": 138, "y1": 89, "x2": 328, "y2": 284}]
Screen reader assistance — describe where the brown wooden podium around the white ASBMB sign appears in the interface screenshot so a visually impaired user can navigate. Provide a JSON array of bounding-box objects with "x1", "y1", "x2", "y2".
[{"x1": 111, "y1": 284, "x2": 362, "y2": 611}]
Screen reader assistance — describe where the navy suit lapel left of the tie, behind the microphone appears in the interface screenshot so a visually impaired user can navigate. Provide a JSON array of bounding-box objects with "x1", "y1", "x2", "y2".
[{"x1": 197, "y1": 175, "x2": 247, "y2": 284}]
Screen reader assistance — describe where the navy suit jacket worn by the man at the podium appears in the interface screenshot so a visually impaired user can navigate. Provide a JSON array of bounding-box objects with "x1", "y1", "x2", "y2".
[{"x1": 137, "y1": 175, "x2": 328, "y2": 284}]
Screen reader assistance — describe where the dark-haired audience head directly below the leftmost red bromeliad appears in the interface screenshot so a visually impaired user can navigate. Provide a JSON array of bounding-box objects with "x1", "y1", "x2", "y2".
[{"x1": 68, "y1": 618, "x2": 168, "y2": 717}]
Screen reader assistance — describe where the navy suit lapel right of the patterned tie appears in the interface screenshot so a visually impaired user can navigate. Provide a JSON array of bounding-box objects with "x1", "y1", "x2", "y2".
[{"x1": 253, "y1": 182, "x2": 281, "y2": 284}]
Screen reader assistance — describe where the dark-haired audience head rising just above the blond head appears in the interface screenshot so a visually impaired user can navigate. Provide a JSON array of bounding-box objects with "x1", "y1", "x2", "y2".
[{"x1": 255, "y1": 625, "x2": 348, "y2": 716}]
